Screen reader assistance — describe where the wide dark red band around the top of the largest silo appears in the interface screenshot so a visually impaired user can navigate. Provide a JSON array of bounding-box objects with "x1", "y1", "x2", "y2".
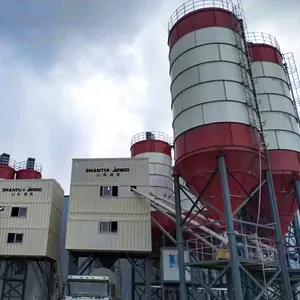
[{"x1": 168, "y1": 7, "x2": 240, "y2": 50}]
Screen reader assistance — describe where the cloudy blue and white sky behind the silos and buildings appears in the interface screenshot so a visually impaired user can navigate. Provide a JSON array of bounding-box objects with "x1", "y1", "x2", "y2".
[{"x1": 0, "y1": 0, "x2": 300, "y2": 192}]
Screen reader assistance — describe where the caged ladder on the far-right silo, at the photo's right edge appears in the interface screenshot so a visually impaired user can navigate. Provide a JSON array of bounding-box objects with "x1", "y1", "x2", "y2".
[{"x1": 283, "y1": 52, "x2": 300, "y2": 123}]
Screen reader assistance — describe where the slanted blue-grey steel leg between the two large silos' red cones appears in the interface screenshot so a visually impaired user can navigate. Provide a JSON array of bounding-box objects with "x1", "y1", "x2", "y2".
[{"x1": 265, "y1": 171, "x2": 293, "y2": 300}]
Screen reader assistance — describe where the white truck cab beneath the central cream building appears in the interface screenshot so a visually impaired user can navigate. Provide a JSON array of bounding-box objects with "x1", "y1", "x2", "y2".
[{"x1": 63, "y1": 275, "x2": 116, "y2": 300}]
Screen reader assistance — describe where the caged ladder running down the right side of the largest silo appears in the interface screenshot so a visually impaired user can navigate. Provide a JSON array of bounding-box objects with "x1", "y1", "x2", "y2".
[{"x1": 232, "y1": 0, "x2": 267, "y2": 150}]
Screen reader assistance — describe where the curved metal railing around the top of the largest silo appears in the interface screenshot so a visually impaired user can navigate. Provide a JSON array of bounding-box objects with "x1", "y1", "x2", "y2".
[{"x1": 168, "y1": 0, "x2": 239, "y2": 31}]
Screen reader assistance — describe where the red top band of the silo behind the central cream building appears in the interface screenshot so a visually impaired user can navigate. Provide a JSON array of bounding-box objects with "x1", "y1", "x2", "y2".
[{"x1": 130, "y1": 140, "x2": 171, "y2": 157}]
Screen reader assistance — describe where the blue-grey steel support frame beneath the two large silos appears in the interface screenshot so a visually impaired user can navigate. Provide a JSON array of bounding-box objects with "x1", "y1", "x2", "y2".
[{"x1": 174, "y1": 154, "x2": 300, "y2": 300}]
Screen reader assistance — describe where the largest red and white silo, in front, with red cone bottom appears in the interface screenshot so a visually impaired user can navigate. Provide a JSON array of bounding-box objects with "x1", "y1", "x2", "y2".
[{"x1": 168, "y1": 0, "x2": 260, "y2": 219}]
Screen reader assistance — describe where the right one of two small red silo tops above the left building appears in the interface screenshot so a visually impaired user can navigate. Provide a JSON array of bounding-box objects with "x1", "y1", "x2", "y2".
[{"x1": 16, "y1": 157, "x2": 43, "y2": 179}]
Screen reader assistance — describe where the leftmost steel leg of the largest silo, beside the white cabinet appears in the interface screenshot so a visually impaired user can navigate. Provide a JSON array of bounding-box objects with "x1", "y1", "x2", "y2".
[{"x1": 174, "y1": 175, "x2": 188, "y2": 300}]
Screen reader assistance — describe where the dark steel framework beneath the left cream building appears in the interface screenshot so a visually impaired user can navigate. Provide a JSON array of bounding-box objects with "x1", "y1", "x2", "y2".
[{"x1": 0, "y1": 257, "x2": 57, "y2": 300}]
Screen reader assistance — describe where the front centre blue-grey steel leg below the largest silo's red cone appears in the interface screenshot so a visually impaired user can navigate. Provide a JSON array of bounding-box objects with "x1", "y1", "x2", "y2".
[{"x1": 218, "y1": 155, "x2": 244, "y2": 300}]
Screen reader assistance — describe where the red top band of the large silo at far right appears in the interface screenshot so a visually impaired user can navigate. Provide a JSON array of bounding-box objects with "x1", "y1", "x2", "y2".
[{"x1": 248, "y1": 43, "x2": 282, "y2": 65}]
